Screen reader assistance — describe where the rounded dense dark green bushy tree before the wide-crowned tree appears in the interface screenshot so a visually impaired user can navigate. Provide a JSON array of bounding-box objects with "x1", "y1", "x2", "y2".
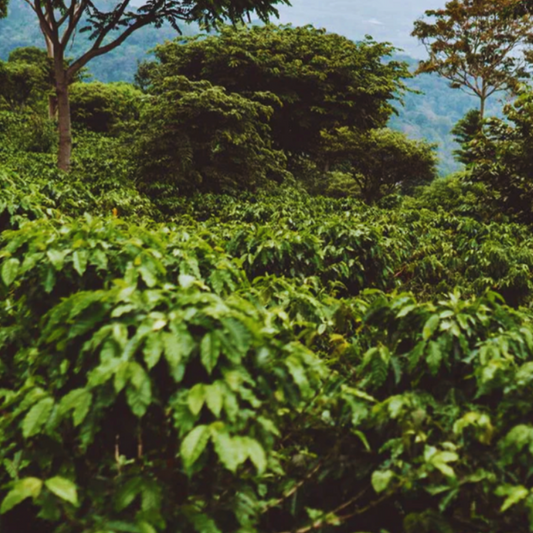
[{"x1": 135, "y1": 76, "x2": 284, "y2": 200}]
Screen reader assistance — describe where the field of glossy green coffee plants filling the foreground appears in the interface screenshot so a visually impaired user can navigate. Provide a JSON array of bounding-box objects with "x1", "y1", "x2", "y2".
[{"x1": 4, "y1": 167, "x2": 533, "y2": 533}]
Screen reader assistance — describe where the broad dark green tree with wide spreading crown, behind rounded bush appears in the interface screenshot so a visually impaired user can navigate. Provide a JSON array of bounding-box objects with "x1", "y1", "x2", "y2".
[{"x1": 144, "y1": 25, "x2": 409, "y2": 156}]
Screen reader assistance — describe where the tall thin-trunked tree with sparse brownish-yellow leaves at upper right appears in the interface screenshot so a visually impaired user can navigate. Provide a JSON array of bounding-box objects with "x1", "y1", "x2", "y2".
[{"x1": 412, "y1": 0, "x2": 533, "y2": 120}]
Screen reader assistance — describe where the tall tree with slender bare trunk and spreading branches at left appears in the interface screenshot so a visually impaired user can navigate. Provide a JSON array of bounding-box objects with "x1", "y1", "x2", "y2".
[{"x1": 0, "y1": 0, "x2": 288, "y2": 170}]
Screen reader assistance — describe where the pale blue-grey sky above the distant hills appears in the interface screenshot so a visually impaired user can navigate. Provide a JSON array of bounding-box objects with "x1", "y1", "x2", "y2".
[{"x1": 279, "y1": 0, "x2": 446, "y2": 58}]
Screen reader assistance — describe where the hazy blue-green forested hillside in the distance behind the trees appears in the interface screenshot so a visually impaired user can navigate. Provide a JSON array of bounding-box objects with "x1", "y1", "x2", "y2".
[{"x1": 0, "y1": 0, "x2": 502, "y2": 175}]
